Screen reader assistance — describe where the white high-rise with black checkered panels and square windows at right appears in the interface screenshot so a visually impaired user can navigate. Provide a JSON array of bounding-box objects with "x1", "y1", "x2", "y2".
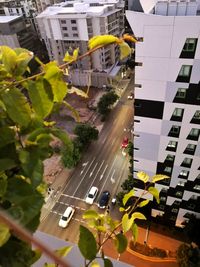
[{"x1": 126, "y1": 0, "x2": 200, "y2": 227}]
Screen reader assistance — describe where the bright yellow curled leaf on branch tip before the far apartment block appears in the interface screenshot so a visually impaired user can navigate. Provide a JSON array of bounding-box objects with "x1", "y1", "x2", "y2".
[{"x1": 88, "y1": 35, "x2": 122, "y2": 49}]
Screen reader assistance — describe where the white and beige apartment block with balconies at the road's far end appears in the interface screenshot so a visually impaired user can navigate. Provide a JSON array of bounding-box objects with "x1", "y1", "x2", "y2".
[{"x1": 37, "y1": 0, "x2": 124, "y2": 87}]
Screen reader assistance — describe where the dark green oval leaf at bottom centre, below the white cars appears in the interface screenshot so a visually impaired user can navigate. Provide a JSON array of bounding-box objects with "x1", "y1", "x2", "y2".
[{"x1": 78, "y1": 225, "x2": 97, "y2": 260}]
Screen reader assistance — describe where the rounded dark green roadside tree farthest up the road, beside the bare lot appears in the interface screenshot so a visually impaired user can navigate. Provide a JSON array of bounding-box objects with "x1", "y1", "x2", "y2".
[{"x1": 97, "y1": 91, "x2": 119, "y2": 117}]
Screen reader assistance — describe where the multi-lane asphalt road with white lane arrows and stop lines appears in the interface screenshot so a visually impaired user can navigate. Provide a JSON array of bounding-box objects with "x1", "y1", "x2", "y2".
[{"x1": 39, "y1": 79, "x2": 133, "y2": 243}]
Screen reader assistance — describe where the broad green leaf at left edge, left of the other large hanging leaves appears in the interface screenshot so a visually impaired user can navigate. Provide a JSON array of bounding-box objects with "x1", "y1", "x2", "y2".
[{"x1": 2, "y1": 88, "x2": 31, "y2": 127}]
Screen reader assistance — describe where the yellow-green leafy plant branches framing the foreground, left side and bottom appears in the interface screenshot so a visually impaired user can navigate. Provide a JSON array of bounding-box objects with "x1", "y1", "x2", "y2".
[{"x1": 0, "y1": 35, "x2": 169, "y2": 267}]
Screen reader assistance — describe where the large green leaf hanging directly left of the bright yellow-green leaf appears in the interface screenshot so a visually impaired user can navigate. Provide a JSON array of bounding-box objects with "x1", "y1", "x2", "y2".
[{"x1": 28, "y1": 78, "x2": 53, "y2": 119}]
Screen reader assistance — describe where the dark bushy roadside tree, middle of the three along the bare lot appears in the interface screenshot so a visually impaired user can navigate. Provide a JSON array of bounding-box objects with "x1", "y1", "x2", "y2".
[{"x1": 74, "y1": 123, "x2": 99, "y2": 148}]
